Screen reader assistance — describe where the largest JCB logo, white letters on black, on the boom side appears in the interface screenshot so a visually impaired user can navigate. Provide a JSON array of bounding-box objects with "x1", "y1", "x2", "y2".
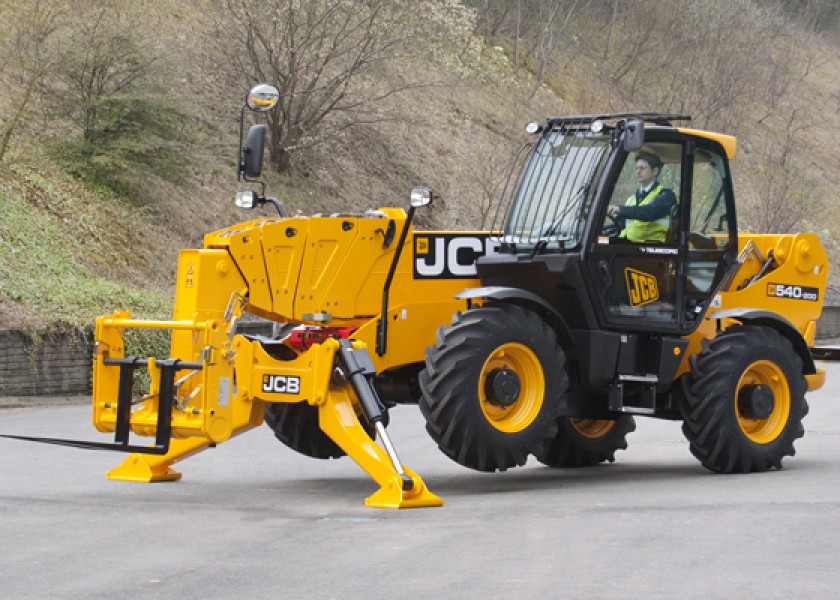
[{"x1": 414, "y1": 233, "x2": 498, "y2": 279}]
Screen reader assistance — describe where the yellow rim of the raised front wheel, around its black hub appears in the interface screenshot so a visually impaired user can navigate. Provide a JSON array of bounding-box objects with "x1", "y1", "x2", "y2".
[{"x1": 478, "y1": 342, "x2": 545, "y2": 433}]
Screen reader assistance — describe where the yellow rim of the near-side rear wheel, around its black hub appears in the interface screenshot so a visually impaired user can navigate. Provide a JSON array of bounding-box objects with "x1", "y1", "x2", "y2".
[{"x1": 735, "y1": 360, "x2": 790, "y2": 444}]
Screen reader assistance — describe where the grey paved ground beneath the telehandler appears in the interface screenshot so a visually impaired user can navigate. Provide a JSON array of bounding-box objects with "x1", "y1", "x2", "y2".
[{"x1": 0, "y1": 365, "x2": 840, "y2": 600}]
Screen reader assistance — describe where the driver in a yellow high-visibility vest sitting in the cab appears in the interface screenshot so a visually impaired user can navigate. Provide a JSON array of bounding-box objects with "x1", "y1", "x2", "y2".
[{"x1": 607, "y1": 151, "x2": 677, "y2": 244}]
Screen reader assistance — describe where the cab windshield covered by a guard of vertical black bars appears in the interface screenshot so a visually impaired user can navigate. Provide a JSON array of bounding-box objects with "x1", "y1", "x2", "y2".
[{"x1": 492, "y1": 131, "x2": 610, "y2": 250}]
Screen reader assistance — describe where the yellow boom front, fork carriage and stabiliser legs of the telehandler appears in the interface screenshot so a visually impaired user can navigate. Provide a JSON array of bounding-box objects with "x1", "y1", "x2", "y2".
[{"x1": 93, "y1": 210, "x2": 475, "y2": 508}]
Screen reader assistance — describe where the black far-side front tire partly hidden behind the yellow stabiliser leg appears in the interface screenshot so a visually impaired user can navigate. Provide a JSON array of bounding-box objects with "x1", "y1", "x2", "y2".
[{"x1": 265, "y1": 402, "x2": 388, "y2": 459}]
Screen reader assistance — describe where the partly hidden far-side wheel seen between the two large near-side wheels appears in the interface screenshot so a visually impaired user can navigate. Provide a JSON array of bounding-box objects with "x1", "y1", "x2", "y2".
[{"x1": 537, "y1": 415, "x2": 636, "y2": 468}]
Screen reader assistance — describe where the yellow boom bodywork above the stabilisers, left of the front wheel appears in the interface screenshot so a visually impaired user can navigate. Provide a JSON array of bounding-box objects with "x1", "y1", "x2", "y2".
[{"x1": 201, "y1": 209, "x2": 478, "y2": 372}]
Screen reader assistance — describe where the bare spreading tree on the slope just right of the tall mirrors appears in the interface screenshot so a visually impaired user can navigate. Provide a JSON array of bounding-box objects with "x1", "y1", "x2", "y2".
[{"x1": 221, "y1": 0, "x2": 436, "y2": 171}]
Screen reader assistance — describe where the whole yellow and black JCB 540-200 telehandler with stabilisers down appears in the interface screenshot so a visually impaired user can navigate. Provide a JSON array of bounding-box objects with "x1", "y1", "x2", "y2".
[{"x1": 23, "y1": 85, "x2": 828, "y2": 508}]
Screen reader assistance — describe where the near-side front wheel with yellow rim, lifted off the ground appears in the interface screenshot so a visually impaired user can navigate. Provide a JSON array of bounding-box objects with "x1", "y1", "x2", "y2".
[{"x1": 419, "y1": 305, "x2": 569, "y2": 471}]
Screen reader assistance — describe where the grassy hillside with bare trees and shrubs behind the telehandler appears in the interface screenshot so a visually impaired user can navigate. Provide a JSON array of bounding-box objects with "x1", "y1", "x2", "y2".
[{"x1": 0, "y1": 0, "x2": 840, "y2": 329}]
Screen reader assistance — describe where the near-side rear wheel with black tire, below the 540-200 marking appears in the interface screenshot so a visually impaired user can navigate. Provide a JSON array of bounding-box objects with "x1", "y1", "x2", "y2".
[{"x1": 682, "y1": 325, "x2": 808, "y2": 473}]
